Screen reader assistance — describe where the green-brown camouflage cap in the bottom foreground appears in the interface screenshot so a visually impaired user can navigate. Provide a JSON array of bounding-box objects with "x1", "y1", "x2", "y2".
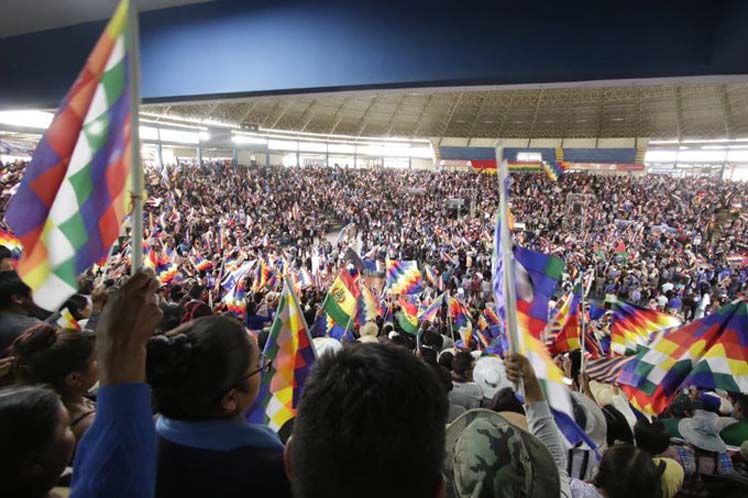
[{"x1": 444, "y1": 409, "x2": 560, "y2": 498}]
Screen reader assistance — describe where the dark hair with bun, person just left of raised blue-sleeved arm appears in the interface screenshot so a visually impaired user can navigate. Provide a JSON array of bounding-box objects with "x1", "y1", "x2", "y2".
[{"x1": 11, "y1": 323, "x2": 95, "y2": 388}]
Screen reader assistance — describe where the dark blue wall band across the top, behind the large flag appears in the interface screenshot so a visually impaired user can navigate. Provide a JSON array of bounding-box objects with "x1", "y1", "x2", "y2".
[{"x1": 0, "y1": 0, "x2": 748, "y2": 107}]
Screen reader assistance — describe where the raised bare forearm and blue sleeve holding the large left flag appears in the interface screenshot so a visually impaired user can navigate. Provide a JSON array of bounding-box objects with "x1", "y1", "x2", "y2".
[{"x1": 70, "y1": 272, "x2": 162, "y2": 498}]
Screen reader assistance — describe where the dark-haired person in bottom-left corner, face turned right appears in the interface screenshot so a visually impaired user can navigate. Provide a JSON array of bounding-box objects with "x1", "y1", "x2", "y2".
[{"x1": 0, "y1": 386, "x2": 75, "y2": 498}]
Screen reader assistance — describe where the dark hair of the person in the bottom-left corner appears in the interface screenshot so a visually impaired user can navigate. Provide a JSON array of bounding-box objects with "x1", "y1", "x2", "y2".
[{"x1": 0, "y1": 386, "x2": 60, "y2": 496}]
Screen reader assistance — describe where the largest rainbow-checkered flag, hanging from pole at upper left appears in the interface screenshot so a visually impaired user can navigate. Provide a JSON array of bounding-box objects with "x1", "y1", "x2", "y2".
[{"x1": 6, "y1": 0, "x2": 132, "y2": 309}]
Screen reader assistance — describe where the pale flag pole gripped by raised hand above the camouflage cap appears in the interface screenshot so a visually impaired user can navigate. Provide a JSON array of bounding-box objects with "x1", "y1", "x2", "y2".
[{"x1": 496, "y1": 140, "x2": 521, "y2": 353}]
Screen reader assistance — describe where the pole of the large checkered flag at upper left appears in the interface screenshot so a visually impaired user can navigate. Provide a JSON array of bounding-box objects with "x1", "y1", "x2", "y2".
[{"x1": 127, "y1": 2, "x2": 144, "y2": 274}]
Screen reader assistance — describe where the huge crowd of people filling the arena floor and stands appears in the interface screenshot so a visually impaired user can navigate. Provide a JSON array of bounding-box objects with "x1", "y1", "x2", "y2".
[{"x1": 0, "y1": 160, "x2": 748, "y2": 498}]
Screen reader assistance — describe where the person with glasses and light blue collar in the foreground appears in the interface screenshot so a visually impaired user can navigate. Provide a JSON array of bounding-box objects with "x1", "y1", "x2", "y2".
[{"x1": 146, "y1": 316, "x2": 291, "y2": 498}]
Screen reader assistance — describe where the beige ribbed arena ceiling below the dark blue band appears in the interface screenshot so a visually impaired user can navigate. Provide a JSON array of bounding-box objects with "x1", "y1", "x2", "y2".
[{"x1": 144, "y1": 83, "x2": 748, "y2": 138}]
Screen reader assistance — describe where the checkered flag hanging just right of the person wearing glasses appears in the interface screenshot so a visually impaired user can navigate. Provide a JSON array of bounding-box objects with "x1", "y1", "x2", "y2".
[{"x1": 247, "y1": 283, "x2": 317, "y2": 432}]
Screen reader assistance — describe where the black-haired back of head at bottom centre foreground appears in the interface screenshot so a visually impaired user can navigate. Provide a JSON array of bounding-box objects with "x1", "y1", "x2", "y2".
[{"x1": 291, "y1": 343, "x2": 449, "y2": 498}]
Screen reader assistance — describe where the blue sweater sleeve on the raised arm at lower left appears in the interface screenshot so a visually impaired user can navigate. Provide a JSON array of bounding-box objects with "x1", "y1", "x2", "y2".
[{"x1": 70, "y1": 384, "x2": 156, "y2": 498}]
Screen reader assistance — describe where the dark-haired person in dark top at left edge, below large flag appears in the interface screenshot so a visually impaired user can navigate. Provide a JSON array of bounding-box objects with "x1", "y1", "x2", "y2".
[{"x1": 0, "y1": 270, "x2": 40, "y2": 356}]
